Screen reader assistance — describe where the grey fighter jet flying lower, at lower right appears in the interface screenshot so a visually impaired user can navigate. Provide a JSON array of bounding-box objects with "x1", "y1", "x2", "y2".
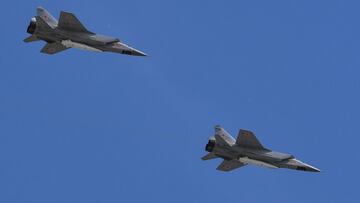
[{"x1": 202, "y1": 125, "x2": 320, "y2": 172}]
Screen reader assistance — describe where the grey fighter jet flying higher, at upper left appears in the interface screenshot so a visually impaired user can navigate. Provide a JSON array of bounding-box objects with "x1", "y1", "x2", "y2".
[{"x1": 24, "y1": 7, "x2": 146, "y2": 56}]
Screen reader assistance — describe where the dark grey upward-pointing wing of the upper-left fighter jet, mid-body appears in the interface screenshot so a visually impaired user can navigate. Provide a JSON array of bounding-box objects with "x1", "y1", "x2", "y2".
[{"x1": 58, "y1": 11, "x2": 91, "y2": 33}]
